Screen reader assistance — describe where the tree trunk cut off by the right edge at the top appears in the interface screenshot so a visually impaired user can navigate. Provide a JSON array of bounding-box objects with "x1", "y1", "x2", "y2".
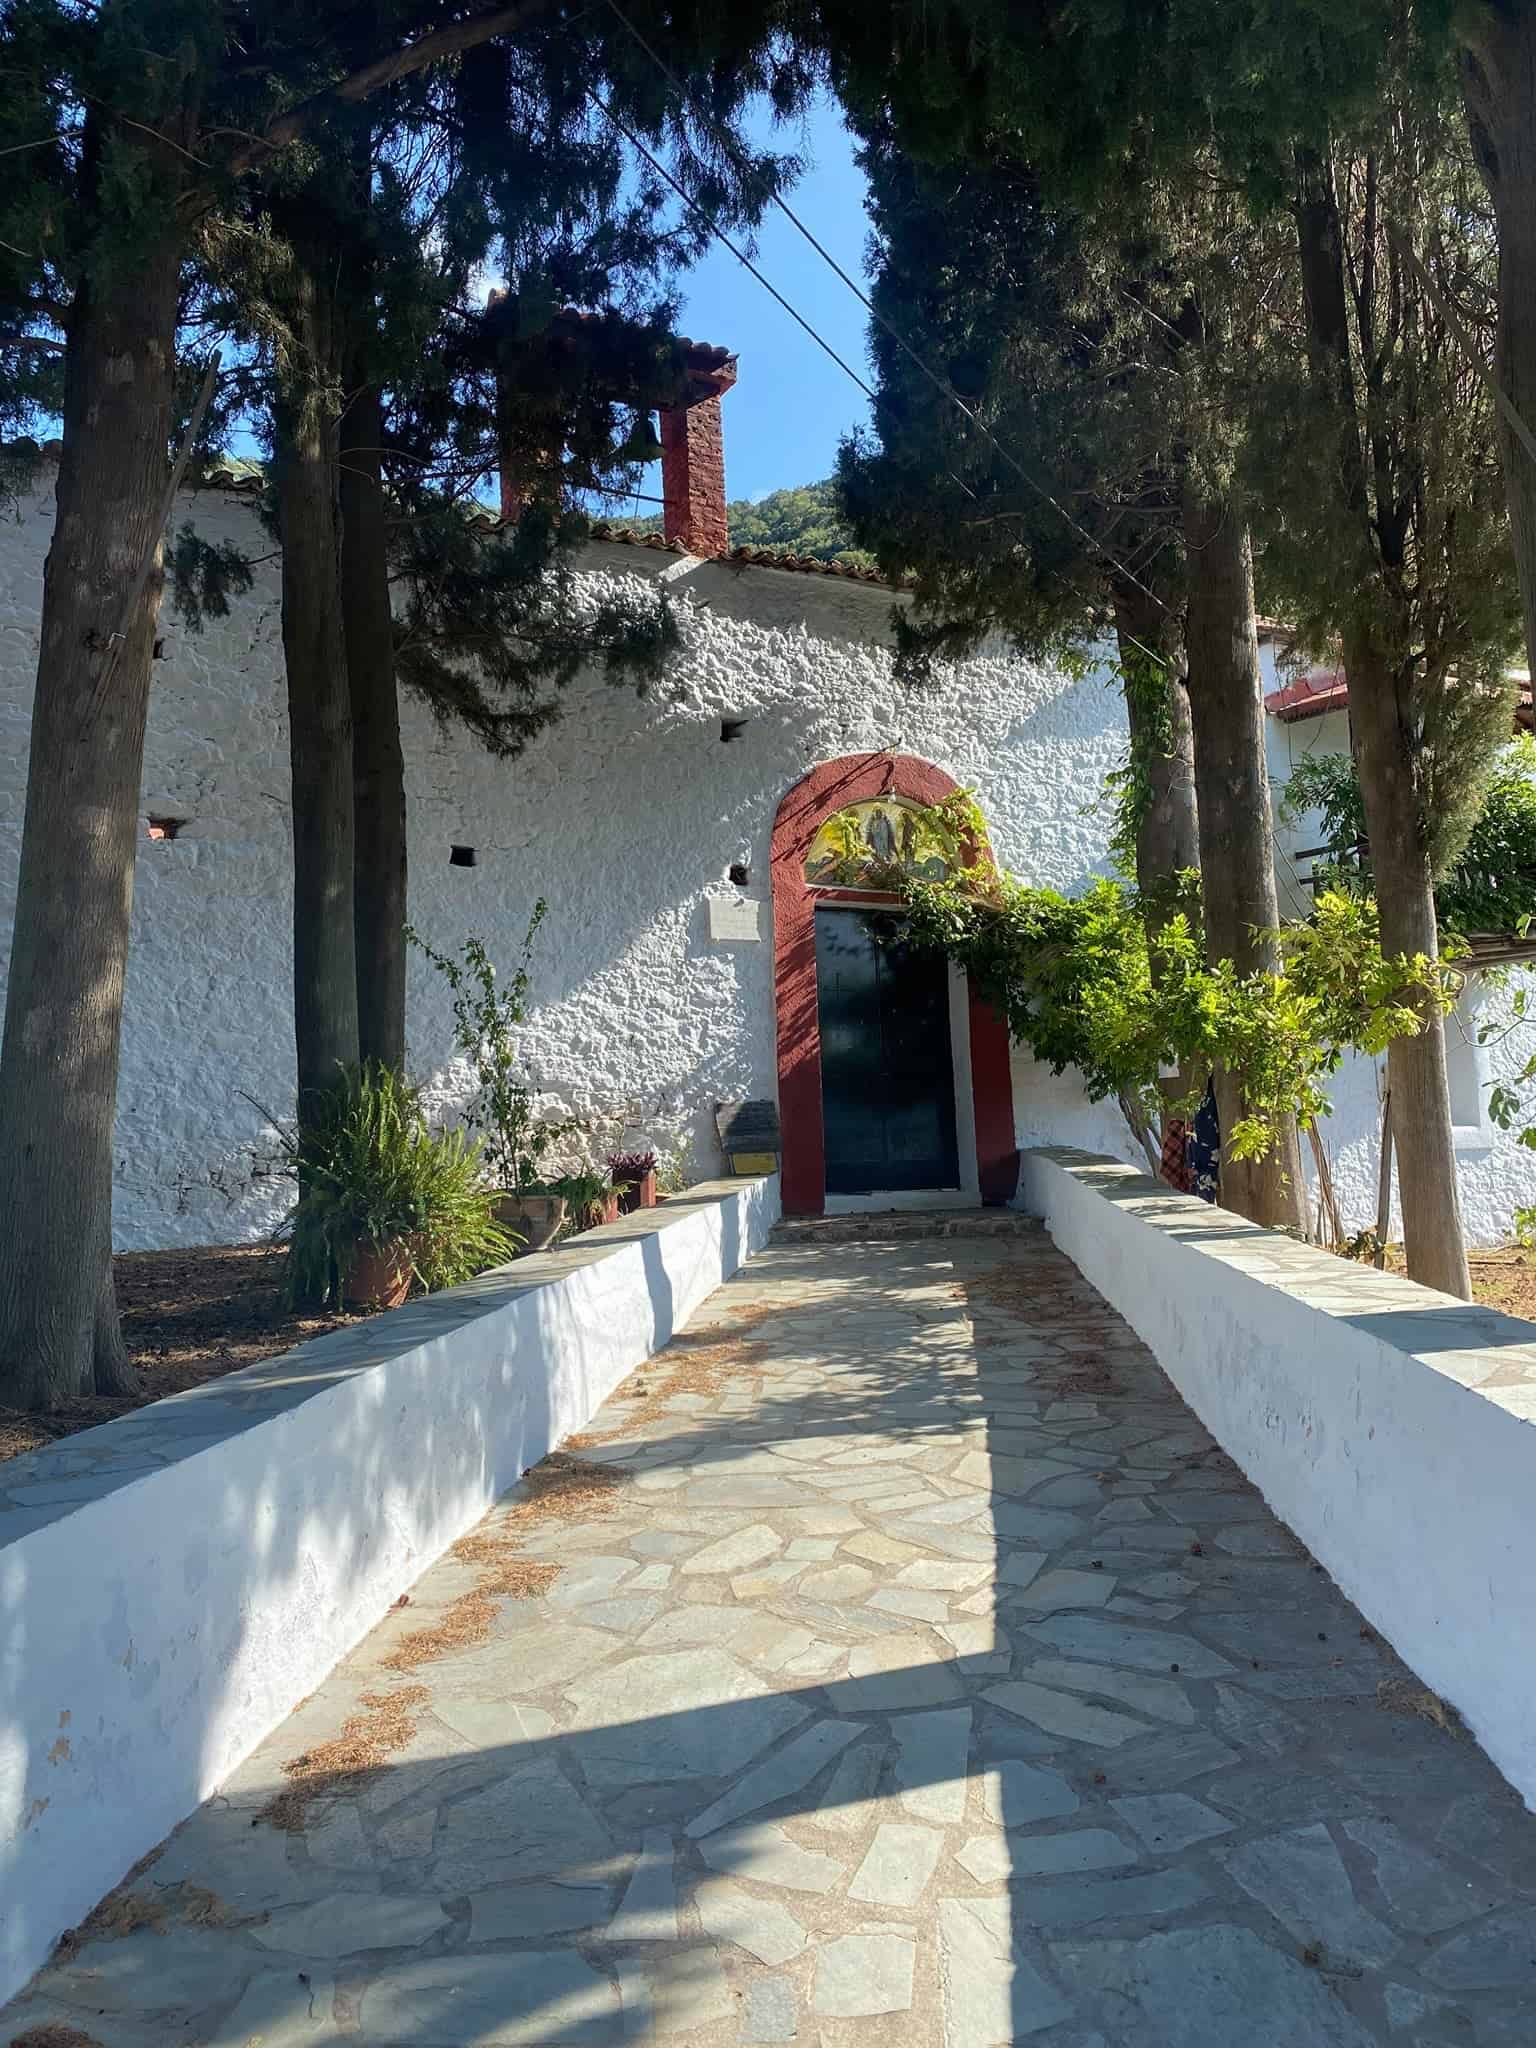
[{"x1": 1458, "y1": 6, "x2": 1536, "y2": 672}]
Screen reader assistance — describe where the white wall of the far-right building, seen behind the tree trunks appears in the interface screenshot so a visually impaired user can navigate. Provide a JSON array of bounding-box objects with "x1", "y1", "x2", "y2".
[{"x1": 1266, "y1": 675, "x2": 1536, "y2": 1245}]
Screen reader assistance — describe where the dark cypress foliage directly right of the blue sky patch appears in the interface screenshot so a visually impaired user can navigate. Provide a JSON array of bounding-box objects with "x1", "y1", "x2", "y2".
[{"x1": 838, "y1": 113, "x2": 1178, "y2": 684}]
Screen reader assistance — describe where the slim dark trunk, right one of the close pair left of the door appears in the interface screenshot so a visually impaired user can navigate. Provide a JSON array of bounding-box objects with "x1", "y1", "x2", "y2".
[{"x1": 340, "y1": 378, "x2": 406, "y2": 1071}]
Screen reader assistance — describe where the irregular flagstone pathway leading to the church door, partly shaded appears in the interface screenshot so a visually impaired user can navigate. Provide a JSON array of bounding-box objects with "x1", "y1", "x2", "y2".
[{"x1": 12, "y1": 1235, "x2": 1536, "y2": 2048}]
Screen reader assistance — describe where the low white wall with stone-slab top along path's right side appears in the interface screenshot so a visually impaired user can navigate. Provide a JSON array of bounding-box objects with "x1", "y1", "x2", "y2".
[{"x1": 1020, "y1": 1149, "x2": 1536, "y2": 1804}]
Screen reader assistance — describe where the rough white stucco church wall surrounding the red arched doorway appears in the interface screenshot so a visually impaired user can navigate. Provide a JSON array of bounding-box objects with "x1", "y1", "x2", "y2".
[{"x1": 0, "y1": 479, "x2": 1128, "y2": 1247}]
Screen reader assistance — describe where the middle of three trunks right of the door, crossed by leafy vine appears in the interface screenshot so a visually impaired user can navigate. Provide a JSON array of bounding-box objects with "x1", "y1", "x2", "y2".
[{"x1": 1184, "y1": 479, "x2": 1307, "y2": 1231}]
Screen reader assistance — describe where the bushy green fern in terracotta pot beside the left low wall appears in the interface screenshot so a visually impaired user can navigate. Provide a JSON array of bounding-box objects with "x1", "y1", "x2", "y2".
[{"x1": 285, "y1": 1063, "x2": 516, "y2": 1303}]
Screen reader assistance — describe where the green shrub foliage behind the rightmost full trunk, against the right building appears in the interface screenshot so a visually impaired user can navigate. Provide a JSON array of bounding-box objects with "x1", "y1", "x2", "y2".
[{"x1": 1284, "y1": 749, "x2": 1536, "y2": 938}]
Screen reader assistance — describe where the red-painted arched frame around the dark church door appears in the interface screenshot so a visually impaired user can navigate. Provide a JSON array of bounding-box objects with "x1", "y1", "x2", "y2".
[{"x1": 772, "y1": 752, "x2": 1018, "y2": 1217}]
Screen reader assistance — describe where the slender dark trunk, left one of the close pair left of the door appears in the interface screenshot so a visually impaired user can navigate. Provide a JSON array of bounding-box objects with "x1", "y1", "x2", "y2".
[{"x1": 276, "y1": 264, "x2": 358, "y2": 1120}]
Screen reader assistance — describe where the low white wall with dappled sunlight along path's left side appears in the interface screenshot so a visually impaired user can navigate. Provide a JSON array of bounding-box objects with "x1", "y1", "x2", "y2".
[{"x1": 0, "y1": 1178, "x2": 778, "y2": 2001}]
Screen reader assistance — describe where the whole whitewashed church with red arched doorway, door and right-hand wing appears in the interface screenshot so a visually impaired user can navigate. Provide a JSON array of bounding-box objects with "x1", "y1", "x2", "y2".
[{"x1": 0, "y1": 352, "x2": 1536, "y2": 1249}]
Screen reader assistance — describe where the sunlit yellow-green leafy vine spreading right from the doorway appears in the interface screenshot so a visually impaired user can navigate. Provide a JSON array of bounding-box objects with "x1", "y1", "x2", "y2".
[{"x1": 885, "y1": 793, "x2": 1460, "y2": 1159}]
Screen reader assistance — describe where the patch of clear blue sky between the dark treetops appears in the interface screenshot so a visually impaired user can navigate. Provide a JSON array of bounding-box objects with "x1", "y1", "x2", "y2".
[{"x1": 663, "y1": 98, "x2": 868, "y2": 512}]
